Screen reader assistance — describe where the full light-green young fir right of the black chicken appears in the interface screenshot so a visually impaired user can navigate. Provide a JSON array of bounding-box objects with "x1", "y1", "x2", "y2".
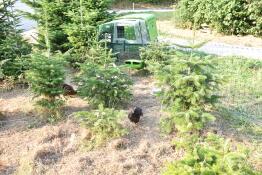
[{"x1": 153, "y1": 54, "x2": 219, "y2": 132}]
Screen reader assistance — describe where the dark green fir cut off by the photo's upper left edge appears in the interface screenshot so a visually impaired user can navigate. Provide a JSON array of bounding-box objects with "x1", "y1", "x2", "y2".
[{"x1": 0, "y1": 0, "x2": 31, "y2": 79}]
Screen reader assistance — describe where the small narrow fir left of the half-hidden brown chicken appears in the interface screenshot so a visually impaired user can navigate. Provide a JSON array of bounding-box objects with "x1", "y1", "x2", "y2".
[{"x1": 26, "y1": 52, "x2": 66, "y2": 121}]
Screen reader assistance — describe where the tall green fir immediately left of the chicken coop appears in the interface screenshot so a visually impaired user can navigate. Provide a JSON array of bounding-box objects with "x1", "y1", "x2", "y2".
[{"x1": 63, "y1": 0, "x2": 112, "y2": 63}]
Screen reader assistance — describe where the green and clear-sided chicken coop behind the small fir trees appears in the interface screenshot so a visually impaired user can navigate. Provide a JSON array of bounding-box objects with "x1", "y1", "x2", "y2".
[{"x1": 99, "y1": 13, "x2": 158, "y2": 62}]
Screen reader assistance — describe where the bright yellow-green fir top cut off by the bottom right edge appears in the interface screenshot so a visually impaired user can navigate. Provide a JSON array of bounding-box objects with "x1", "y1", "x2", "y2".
[{"x1": 161, "y1": 133, "x2": 261, "y2": 175}]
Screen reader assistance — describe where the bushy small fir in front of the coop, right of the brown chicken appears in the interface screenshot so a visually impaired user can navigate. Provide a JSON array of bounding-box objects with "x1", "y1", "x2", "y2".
[{"x1": 75, "y1": 61, "x2": 132, "y2": 108}]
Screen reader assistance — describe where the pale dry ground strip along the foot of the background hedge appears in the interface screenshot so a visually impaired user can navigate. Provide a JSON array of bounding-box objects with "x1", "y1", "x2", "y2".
[{"x1": 157, "y1": 20, "x2": 262, "y2": 47}]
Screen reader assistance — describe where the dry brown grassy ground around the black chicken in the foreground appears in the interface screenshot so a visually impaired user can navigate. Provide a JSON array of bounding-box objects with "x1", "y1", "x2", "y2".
[{"x1": 0, "y1": 77, "x2": 179, "y2": 175}]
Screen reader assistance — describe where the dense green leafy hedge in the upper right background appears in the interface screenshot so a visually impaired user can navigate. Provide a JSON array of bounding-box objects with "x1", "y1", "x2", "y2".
[{"x1": 175, "y1": 0, "x2": 262, "y2": 36}]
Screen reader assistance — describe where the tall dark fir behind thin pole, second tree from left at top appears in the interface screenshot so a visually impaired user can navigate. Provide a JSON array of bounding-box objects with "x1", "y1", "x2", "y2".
[{"x1": 21, "y1": 0, "x2": 72, "y2": 52}]
